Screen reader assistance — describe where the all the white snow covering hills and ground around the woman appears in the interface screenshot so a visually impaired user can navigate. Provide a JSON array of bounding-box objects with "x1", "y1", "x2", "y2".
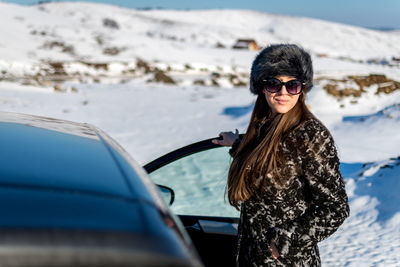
[{"x1": 0, "y1": 2, "x2": 400, "y2": 267}]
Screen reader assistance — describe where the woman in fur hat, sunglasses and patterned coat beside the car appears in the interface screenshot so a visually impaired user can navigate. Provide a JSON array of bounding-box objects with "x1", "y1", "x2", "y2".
[{"x1": 213, "y1": 44, "x2": 349, "y2": 266}]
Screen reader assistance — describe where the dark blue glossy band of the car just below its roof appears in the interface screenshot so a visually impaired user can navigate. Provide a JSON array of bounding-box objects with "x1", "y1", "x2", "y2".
[{"x1": 0, "y1": 185, "x2": 156, "y2": 233}]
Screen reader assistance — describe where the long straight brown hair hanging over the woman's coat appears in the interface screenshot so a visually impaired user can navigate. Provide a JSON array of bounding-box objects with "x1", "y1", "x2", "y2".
[{"x1": 227, "y1": 92, "x2": 313, "y2": 209}]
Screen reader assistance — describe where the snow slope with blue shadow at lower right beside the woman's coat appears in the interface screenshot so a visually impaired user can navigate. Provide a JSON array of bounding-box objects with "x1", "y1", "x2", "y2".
[{"x1": 320, "y1": 158, "x2": 400, "y2": 267}]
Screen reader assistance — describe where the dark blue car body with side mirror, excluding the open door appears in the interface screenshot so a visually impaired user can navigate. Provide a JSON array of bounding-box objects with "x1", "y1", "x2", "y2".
[{"x1": 0, "y1": 112, "x2": 203, "y2": 266}]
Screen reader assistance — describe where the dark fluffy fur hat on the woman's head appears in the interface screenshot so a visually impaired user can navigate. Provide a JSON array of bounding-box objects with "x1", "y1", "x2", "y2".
[{"x1": 250, "y1": 44, "x2": 313, "y2": 94}]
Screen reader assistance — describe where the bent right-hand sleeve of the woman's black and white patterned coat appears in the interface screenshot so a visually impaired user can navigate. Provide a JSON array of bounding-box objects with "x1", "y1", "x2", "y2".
[{"x1": 268, "y1": 124, "x2": 350, "y2": 257}]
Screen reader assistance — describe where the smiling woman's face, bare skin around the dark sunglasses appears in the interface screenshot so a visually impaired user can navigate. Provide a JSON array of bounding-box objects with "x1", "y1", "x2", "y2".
[{"x1": 263, "y1": 76, "x2": 300, "y2": 114}]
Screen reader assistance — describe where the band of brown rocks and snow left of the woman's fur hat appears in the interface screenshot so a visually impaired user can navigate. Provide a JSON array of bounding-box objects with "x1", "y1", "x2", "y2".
[{"x1": 0, "y1": 58, "x2": 249, "y2": 88}]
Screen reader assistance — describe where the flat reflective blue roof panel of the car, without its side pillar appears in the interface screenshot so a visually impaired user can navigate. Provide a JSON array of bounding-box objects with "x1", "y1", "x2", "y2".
[{"x1": 0, "y1": 113, "x2": 132, "y2": 197}]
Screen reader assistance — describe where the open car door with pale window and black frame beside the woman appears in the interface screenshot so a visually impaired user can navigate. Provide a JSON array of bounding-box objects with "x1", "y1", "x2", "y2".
[{"x1": 144, "y1": 139, "x2": 239, "y2": 266}]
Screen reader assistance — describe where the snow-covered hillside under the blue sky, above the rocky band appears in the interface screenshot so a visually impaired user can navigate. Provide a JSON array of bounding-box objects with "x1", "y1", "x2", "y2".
[{"x1": 0, "y1": 2, "x2": 400, "y2": 64}]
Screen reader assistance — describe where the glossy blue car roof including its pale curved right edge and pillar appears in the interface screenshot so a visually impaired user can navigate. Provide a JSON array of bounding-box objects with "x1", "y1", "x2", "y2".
[{"x1": 0, "y1": 112, "x2": 172, "y2": 223}]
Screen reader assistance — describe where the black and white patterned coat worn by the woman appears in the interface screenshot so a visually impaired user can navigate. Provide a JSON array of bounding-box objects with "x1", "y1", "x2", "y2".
[{"x1": 233, "y1": 119, "x2": 349, "y2": 266}]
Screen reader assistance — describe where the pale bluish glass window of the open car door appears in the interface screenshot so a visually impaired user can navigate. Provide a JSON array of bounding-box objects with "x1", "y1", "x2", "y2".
[{"x1": 150, "y1": 147, "x2": 239, "y2": 217}]
